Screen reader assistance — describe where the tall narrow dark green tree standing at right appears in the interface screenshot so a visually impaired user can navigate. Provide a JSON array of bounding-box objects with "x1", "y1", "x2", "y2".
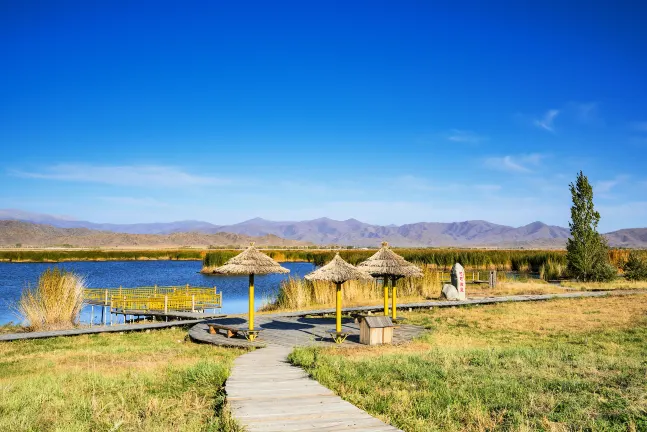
[{"x1": 566, "y1": 171, "x2": 617, "y2": 282}]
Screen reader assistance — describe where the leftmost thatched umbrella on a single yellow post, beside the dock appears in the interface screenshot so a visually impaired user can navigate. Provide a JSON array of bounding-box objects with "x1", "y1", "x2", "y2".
[{"x1": 214, "y1": 243, "x2": 290, "y2": 340}]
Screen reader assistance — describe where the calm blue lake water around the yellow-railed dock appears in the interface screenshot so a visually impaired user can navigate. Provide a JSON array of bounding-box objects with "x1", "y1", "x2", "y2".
[{"x1": 0, "y1": 261, "x2": 314, "y2": 325}]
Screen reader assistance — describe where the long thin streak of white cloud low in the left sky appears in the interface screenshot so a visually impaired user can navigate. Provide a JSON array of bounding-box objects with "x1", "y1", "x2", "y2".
[{"x1": 9, "y1": 164, "x2": 230, "y2": 187}]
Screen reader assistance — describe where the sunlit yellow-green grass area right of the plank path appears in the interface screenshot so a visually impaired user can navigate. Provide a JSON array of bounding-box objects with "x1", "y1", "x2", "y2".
[{"x1": 291, "y1": 295, "x2": 647, "y2": 431}]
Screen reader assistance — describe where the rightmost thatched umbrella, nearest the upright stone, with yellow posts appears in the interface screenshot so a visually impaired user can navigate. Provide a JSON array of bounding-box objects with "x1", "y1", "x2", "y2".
[{"x1": 357, "y1": 242, "x2": 423, "y2": 321}]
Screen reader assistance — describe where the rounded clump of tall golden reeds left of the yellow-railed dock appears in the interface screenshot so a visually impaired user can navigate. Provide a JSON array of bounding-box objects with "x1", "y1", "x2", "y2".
[{"x1": 18, "y1": 268, "x2": 84, "y2": 331}]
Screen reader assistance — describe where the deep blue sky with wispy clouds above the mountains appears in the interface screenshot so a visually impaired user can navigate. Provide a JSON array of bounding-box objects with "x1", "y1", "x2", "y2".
[{"x1": 0, "y1": 0, "x2": 647, "y2": 231}]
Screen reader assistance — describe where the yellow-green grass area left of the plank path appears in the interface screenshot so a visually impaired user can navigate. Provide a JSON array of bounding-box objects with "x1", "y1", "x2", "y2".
[{"x1": 0, "y1": 329, "x2": 242, "y2": 432}]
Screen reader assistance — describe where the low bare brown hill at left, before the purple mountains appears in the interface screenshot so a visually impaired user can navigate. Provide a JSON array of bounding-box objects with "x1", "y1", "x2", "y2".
[{"x1": 0, "y1": 220, "x2": 308, "y2": 248}]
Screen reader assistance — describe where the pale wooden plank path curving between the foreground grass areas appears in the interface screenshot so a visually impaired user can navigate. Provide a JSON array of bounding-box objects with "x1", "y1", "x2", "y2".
[{"x1": 226, "y1": 346, "x2": 399, "y2": 432}]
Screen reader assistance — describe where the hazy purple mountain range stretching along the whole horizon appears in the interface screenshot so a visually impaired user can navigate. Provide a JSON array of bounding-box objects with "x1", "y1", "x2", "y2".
[{"x1": 0, "y1": 210, "x2": 647, "y2": 248}]
